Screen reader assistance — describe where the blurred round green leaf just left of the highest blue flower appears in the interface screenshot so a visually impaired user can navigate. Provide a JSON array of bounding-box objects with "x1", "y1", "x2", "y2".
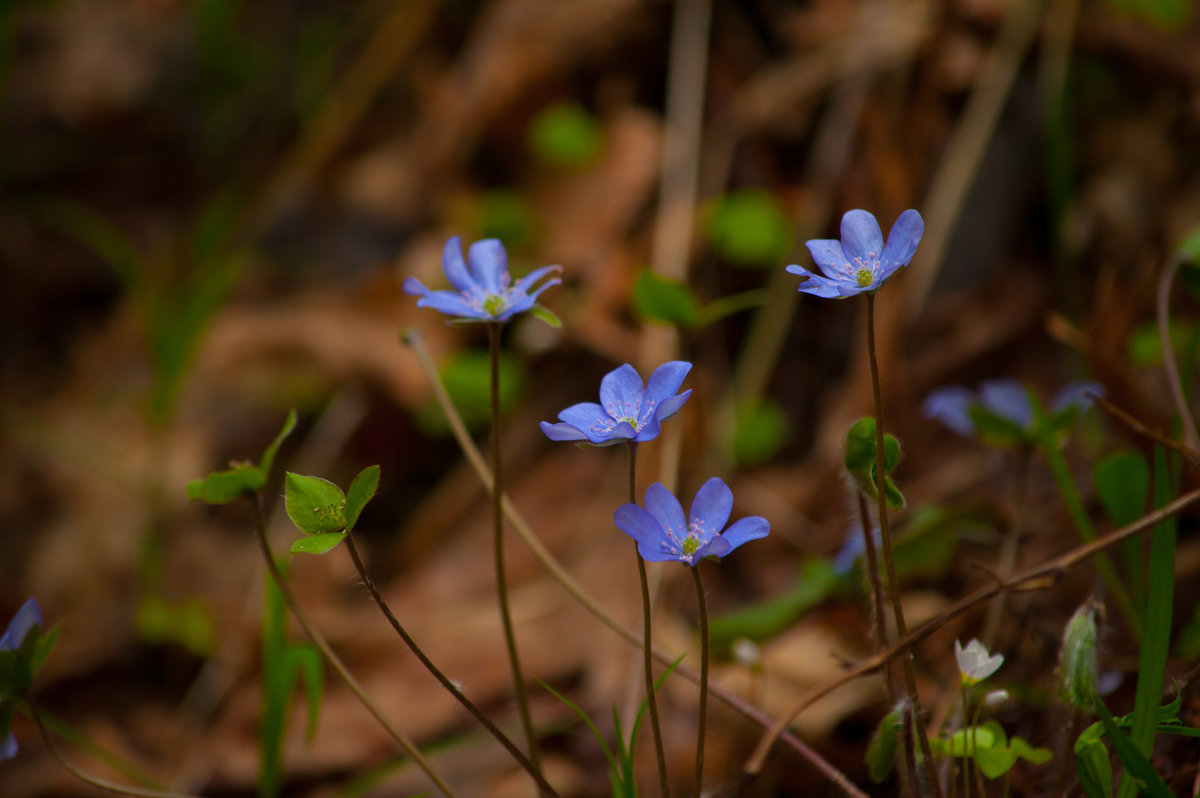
[{"x1": 704, "y1": 188, "x2": 793, "y2": 266}]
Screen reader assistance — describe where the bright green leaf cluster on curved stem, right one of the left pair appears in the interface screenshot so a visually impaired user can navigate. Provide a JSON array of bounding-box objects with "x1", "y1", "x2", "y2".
[{"x1": 283, "y1": 466, "x2": 379, "y2": 554}]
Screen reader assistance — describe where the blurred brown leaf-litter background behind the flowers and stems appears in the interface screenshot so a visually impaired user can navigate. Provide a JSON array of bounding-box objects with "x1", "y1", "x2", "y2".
[{"x1": 0, "y1": 0, "x2": 1200, "y2": 798}]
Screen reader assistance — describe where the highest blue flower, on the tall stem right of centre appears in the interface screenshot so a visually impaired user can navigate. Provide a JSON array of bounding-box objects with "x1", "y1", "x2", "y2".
[{"x1": 787, "y1": 210, "x2": 925, "y2": 299}]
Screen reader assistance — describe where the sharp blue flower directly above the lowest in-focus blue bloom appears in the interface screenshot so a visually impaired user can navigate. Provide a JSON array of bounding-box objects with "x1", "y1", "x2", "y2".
[{"x1": 540, "y1": 360, "x2": 691, "y2": 446}]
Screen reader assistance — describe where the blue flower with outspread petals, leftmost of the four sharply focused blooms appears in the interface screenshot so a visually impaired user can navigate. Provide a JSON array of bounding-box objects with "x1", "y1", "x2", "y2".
[{"x1": 404, "y1": 235, "x2": 563, "y2": 322}]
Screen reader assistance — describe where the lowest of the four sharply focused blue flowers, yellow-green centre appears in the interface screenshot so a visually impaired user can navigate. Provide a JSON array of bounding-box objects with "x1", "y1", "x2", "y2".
[{"x1": 612, "y1": 476, "x2": 770, "y2": 566}]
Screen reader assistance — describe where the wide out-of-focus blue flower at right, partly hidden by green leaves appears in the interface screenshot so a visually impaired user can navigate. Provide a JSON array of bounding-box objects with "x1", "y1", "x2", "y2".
[{"x1": 922, "y1": 378, "x2": 1104, "y2": 443}]
